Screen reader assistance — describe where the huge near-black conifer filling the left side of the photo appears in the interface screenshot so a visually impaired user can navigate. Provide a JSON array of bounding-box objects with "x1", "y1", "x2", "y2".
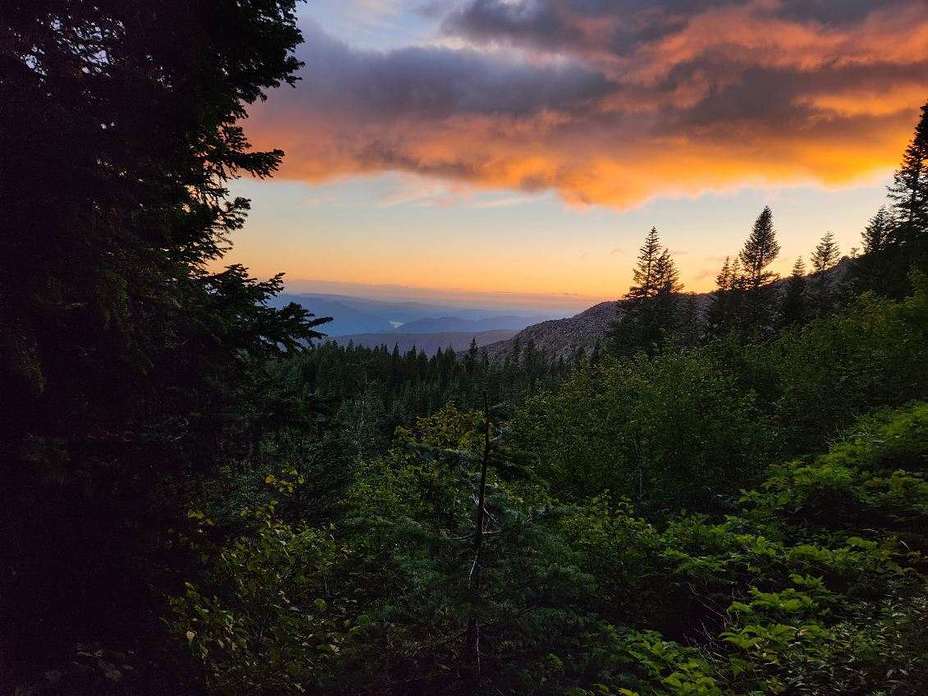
[{"x1": 0, "y1": 0, "x2": 318, "y2": 681}]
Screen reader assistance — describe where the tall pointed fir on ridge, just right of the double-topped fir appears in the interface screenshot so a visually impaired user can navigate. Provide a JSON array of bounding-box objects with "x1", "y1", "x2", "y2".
[{"x1": 738, "y1": 206, "x2": 780, "y2": 337}]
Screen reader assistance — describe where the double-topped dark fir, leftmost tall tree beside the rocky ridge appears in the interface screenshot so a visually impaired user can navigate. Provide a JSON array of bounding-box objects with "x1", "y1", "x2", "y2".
[{"x1": 609, "y1": 227, "x2": 682, "y2": 355}]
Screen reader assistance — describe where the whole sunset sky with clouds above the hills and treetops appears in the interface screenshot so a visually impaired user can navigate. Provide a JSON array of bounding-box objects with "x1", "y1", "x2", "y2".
[{"x1": 219, "y1": 0, "x2": 928, "y2": 307}]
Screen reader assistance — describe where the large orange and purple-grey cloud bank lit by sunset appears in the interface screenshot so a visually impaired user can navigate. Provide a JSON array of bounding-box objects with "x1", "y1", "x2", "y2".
[{"x1": 249, "y1": 0, "x2": 928, "y2": 206}]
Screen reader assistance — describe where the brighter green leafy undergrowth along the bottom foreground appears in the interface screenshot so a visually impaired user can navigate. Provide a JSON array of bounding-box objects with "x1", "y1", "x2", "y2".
[{"x1": 173, "y1": 394, "x2": 928, "y2": 694}]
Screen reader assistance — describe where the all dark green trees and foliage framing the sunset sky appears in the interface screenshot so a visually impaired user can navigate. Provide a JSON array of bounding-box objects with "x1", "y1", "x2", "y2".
[{"x1": 0, "y1": 0, "x2": 928, "y2": 696}]
